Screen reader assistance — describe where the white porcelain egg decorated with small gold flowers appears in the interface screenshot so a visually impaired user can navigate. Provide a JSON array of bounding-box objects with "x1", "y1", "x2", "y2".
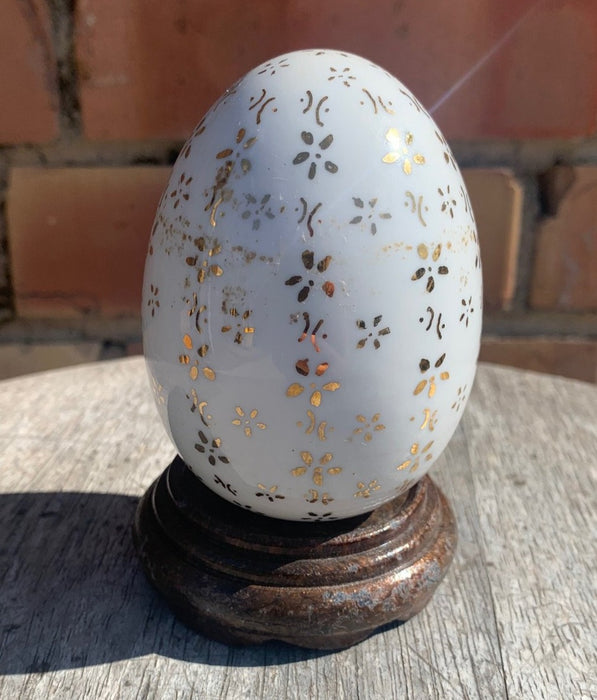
[{"x1": 143, "y1": 50, "x2": 482, "y2": 520}]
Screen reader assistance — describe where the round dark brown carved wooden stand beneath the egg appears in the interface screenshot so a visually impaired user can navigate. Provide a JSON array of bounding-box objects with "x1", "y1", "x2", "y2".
[{"x1": 133, "y1": 457, "x2": 456, "y2": 649}]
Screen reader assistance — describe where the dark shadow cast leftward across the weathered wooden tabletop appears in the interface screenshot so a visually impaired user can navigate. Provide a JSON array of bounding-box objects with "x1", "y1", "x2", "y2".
[{"x1": 0, "y1": 492, "x2": 330, "y2": 675}]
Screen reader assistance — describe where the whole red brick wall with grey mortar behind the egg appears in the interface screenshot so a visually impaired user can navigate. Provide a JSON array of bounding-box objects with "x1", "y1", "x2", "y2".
[{"x1": 0, "y1": 0, "x2": 597, "y2": 381}]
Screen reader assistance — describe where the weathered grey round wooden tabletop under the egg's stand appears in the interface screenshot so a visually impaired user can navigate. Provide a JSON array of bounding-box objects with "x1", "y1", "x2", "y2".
[{"x1": 0, "y1": 358, "x2": 597, "y2": 700}]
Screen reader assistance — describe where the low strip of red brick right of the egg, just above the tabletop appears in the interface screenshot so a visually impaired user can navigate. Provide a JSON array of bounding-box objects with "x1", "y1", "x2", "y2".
[{"x1": 480, "y1": 338, "x2": 597, "y2": 382}]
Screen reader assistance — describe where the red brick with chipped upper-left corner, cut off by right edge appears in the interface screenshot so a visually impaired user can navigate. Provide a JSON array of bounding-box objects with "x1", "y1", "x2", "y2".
[{"x1": 530, "y1": 166, "x2": 597, "y2": 311}]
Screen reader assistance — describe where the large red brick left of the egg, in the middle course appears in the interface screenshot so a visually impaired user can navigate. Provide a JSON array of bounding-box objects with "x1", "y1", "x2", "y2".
[{"x1": 7, "y1": 167, "x2": 170, "y2": 317}]
